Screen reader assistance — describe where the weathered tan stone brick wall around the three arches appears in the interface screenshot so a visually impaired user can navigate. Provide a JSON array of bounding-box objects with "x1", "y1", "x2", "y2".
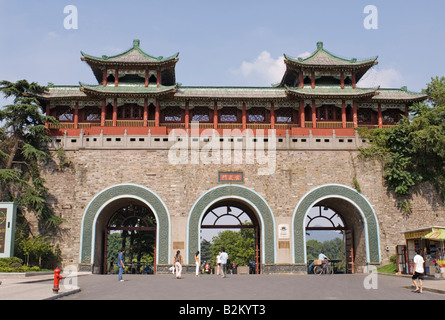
[{"x1": 38, "y1": 149, "x2": 445, "y2": 265}]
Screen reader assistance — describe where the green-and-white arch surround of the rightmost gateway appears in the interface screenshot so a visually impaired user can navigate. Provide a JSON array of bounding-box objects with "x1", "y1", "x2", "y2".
[{"x1": 292, "y1": 184, "x2": 381, "y2": 272}]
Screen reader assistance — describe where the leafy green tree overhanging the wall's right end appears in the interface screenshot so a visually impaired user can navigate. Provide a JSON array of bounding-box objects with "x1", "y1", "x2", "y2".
[{"x1": 359, "y1": 77, "x2": 445, "y2": 200}]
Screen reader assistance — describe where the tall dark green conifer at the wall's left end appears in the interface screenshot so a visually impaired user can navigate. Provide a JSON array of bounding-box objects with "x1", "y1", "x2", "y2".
[{"x1": 0, "y1": 80, "x2": 62, "y2": 228}]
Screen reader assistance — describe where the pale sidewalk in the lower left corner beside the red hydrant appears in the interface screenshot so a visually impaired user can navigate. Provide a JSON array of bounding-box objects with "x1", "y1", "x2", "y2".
[{"x1": 0, "y1": 273, "x2": 85, "y2": 300}]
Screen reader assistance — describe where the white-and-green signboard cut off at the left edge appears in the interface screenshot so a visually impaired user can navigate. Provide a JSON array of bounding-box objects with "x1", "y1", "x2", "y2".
[{"x1": 0, "y1": 202, "x2": 17, "y2": 258}]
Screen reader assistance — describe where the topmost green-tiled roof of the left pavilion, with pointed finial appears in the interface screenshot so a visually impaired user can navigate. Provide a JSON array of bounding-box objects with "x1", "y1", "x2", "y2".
[{"x1": 81, "y1": 40, "x2": 179, "y2": 65}]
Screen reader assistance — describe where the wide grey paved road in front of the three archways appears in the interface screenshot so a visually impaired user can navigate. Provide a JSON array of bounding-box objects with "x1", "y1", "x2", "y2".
[{"x1": 62, "y1": 274, "x2": 445, "y2": 301}]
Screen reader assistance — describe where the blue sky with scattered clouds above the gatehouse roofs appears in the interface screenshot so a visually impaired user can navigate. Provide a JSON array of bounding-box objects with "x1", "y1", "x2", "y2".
[{"x1": 0, "y1": 0, "x2": 445, "y2": 95}]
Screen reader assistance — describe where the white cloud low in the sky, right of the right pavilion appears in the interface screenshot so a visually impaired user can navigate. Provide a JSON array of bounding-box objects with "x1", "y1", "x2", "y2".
[{"x1": 357, "y1": 68, "x2": 404, "y2": 88}]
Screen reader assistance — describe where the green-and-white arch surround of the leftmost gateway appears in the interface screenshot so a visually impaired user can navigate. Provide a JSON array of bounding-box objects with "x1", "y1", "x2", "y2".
[{"x1": 79, "y1": 184, "x2": 170, "y2": 271}]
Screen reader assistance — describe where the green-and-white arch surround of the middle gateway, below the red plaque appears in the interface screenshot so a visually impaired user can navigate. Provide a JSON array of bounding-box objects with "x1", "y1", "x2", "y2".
[{"x1": 187, "y1": 185, "x2": 276, "y2": 264}]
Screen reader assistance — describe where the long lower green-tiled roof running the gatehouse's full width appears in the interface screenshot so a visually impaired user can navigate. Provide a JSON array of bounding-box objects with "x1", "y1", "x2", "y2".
[{"x1": 38, "y1": 83, "x2": 428, "y2": 103}]
